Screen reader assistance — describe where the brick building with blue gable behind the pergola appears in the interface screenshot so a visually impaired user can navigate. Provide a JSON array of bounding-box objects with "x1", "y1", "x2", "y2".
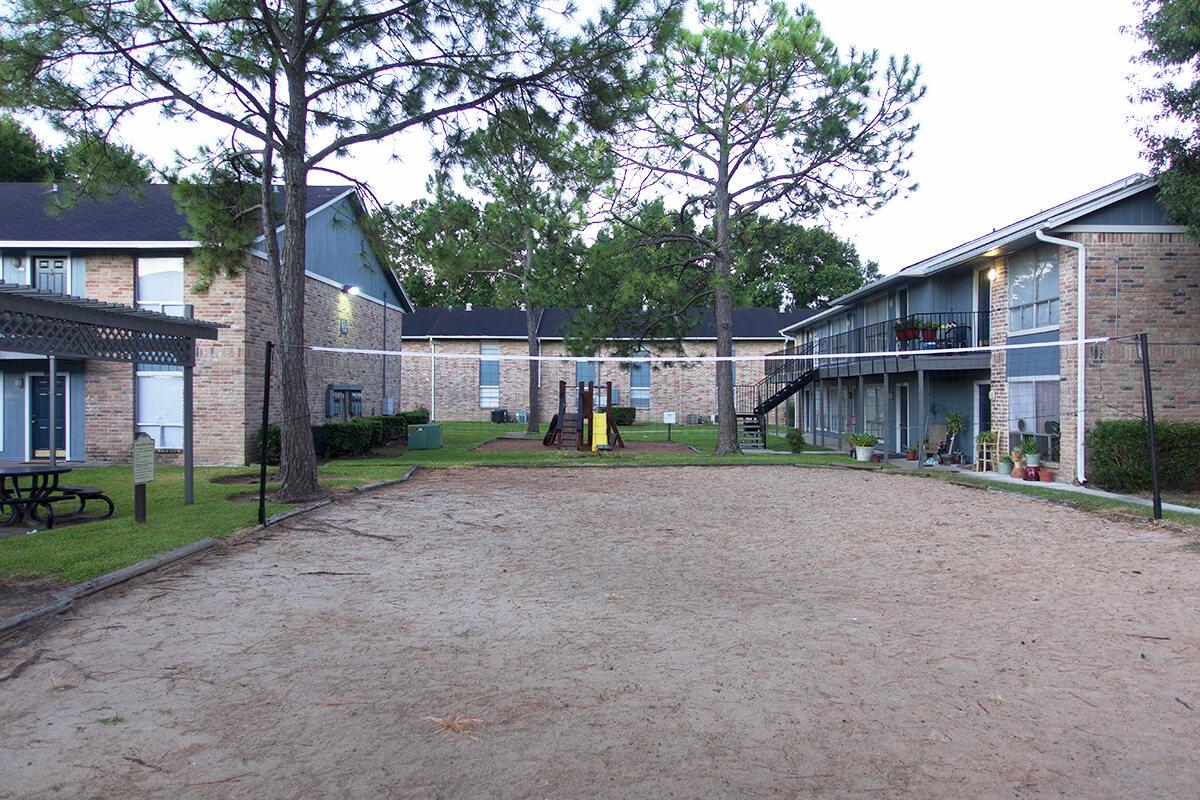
[{"x1": 0, "y1": 184, "x2": 410, "y2": 464}]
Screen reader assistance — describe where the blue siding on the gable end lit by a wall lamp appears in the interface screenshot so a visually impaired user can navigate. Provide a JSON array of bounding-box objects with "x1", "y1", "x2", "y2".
[{"x1": 297, "y1": 198, "x2": 401, "y2": 306}]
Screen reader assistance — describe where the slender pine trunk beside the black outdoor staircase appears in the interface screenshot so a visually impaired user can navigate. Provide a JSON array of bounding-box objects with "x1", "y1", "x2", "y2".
[{"x1": 713, "y1": 158, "x2": 742, "y2": 456}]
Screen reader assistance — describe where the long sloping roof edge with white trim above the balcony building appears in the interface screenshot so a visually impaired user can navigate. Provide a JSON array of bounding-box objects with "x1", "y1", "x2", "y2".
[{"x1": 780, "y1": 174, "x2": 1158, "y2": 333}]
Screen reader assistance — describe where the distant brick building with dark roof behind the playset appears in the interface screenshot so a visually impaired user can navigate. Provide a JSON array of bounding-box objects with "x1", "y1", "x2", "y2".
[{"x1": 400, "y1": 306, "x2": 812, "y2": 422}]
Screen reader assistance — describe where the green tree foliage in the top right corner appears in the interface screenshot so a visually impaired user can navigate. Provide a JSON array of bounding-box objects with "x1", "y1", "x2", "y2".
[{"x1": 1135, "y1": 0, "x2": 1200, "y2": 237}]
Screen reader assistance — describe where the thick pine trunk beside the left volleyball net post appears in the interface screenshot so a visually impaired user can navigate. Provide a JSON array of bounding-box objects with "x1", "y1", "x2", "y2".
[{"x1": 273, "y1": 74, "x2": 322, "y2": 503}]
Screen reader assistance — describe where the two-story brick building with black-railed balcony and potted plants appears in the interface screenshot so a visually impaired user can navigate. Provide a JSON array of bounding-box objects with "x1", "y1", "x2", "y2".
[{"x1": 786, "y1": 175, "x2": 1200, "y2": 481}]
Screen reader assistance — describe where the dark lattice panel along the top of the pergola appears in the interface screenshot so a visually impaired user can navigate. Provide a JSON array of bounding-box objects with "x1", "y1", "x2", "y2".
[{"x1": 0, "y1": 311, "x2": 193, "y2": 367}]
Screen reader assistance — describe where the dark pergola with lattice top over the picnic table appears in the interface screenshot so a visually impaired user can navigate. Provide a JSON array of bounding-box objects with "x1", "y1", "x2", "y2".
[{"x1": 0, "y1": 282, "x2": 222, "y2": 505}]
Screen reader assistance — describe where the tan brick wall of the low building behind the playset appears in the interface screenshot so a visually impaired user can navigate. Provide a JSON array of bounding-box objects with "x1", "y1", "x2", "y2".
[{"x1": 401, "y1": 339, "x2": 782, "y2": 422}]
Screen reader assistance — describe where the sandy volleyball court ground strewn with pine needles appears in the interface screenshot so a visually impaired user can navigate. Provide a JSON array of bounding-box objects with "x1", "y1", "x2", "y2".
[{"x1": 0, "y1": 467, "x2": 1200, "y2": 799}]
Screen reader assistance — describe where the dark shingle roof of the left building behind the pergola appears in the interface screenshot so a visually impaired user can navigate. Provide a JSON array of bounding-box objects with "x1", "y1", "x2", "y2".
[{"x1": 0, "y1": 182, "x2": 350, "y2": 242}]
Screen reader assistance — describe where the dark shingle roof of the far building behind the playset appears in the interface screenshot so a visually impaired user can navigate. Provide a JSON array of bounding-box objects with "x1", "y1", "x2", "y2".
[{"x1": 404, "y1": 307, "x2": 816, "y2": 339}]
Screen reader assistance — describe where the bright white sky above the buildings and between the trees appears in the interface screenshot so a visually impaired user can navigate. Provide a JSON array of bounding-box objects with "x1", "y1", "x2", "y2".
[{"x1": 79, "y1": 0, "x2": 1147, "y2": 273}]
